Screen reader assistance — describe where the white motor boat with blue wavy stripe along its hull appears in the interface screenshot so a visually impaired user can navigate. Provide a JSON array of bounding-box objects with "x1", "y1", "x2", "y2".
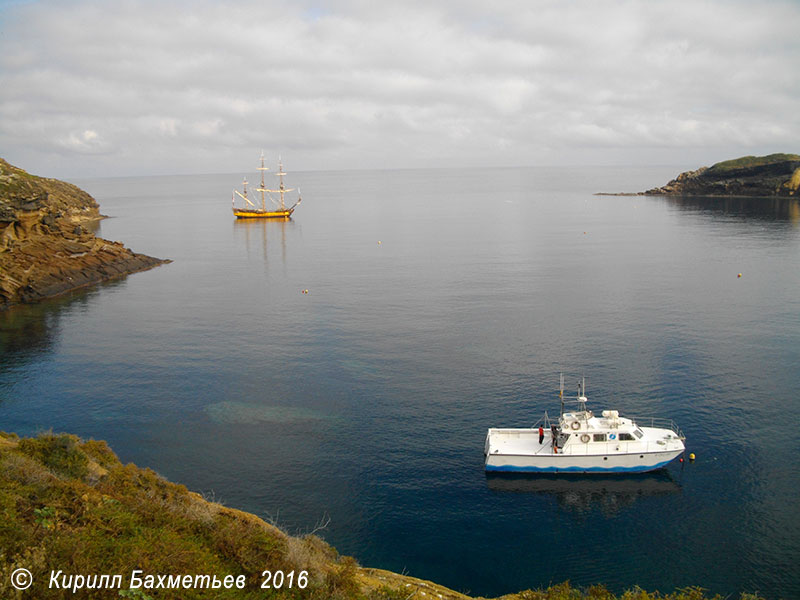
[{"x1": 484, "y1": 375, "x2": 686, "y2": 473}]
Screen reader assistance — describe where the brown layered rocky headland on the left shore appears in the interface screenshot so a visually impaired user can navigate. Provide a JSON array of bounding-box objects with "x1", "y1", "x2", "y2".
[{"x1": 0, "y1": 159, "x2": 170, "y2": 310}]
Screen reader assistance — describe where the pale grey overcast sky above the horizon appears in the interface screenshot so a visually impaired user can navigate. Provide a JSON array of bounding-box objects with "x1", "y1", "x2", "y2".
[{"x1": 0, "y1": 0, "x2": 800, "y2": 177}]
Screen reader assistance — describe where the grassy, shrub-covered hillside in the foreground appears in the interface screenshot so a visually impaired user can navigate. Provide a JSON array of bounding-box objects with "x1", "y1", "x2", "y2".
[{"x1": 0, "y1": 432, "x2": 768, "y2": 600}]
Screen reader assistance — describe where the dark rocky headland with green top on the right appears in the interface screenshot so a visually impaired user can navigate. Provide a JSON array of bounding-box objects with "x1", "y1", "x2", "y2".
[{"x1": 642, "y1": 154, "x2": 800, "y2": 197}]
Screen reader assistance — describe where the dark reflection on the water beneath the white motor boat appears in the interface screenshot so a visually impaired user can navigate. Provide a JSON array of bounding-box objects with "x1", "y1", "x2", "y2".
[{"x1": 486, "y1": 469, "x2": 681, "y2": 514}]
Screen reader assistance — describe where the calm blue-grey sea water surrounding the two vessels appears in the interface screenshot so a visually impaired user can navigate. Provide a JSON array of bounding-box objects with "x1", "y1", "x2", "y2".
[{"x1": 0, "y1": 168, "x2": 800, "y2": 599}]
